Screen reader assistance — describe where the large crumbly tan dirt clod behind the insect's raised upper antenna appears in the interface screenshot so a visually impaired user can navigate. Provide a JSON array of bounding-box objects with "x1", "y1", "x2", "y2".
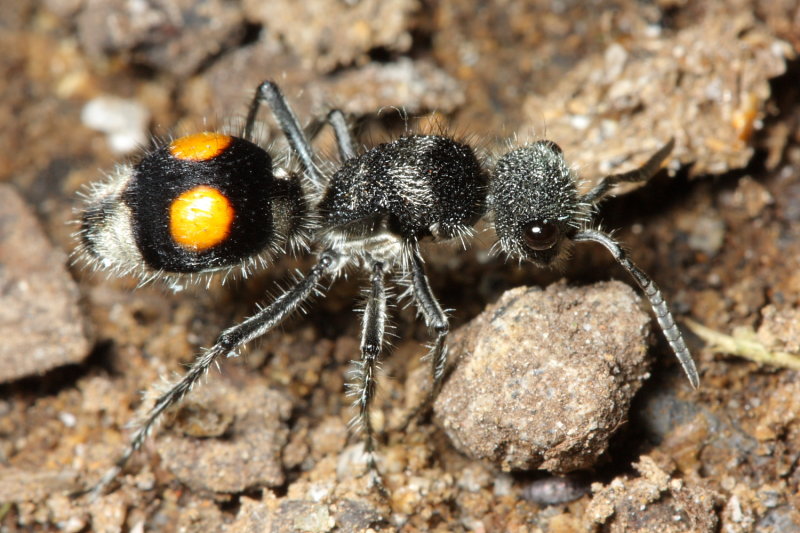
[{"x1": 525, "y1": 7, "x2": 792, "y2": 182}]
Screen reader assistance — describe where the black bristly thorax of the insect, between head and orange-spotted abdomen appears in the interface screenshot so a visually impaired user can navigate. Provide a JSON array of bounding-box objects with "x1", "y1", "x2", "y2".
[{"x1": 318, "y1": 135, "x2": 487, "y2": 240}]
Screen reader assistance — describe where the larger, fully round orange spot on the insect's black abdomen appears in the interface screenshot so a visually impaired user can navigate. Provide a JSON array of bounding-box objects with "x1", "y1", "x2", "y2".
[{"x1": 169, "y1": 185, "x2": 235, "y2": 251}]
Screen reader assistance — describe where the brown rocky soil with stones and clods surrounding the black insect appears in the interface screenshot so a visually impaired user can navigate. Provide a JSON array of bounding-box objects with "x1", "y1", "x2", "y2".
[{"x1": 0, "y1": 0, "x2": 800, "y2": 532}]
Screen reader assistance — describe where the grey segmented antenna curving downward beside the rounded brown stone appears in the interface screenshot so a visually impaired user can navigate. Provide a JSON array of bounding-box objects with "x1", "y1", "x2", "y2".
[{"x1": 572, "y1": 229, "x2": 700, "y2": 389}]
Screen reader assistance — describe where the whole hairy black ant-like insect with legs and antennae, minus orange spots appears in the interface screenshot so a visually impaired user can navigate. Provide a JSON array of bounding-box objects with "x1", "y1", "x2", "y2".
[{"x1": 81, "y1": 81, "x2": 699, "y2": 494}]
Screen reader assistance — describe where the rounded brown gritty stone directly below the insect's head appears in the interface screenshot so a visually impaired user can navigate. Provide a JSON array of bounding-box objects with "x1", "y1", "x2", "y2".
[{"x1": 434, "y1": 282, "x2": 650, "y2": 472}]
